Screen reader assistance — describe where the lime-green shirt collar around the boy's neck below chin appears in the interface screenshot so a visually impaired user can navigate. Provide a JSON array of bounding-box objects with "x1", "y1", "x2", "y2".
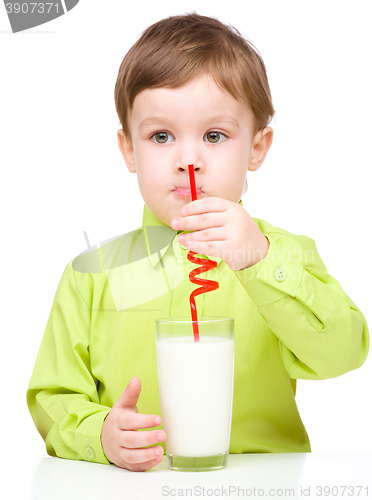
[{"x1": 139, "y1": 200, "x2": 243, "y2": 267}]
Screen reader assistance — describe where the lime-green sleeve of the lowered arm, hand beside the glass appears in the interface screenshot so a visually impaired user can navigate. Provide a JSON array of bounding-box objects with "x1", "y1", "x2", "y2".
[{"x1": 27, "y1": 261, "x2": 111, "y2": 464}]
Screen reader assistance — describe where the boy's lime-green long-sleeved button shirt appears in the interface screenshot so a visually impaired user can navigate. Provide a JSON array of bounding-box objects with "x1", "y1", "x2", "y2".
[{"x1": 27, "y1": 201, "x2": 369, "y2": 464}]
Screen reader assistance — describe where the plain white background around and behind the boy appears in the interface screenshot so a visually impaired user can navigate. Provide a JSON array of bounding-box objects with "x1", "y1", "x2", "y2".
[{"x1": 0, "y1": 0, "x2": 372, "y2": 476}]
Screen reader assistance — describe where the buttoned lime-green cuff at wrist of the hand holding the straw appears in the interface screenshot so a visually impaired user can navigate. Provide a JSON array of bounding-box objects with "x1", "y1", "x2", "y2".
[{"x1": 235, "y1": 234, "x2": 303, "y2": 306}]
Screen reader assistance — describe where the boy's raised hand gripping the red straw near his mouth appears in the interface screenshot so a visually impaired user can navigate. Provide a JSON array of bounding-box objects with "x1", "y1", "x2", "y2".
[{"x1": 171, "y1": 197, "x2": 270, "y2": 271}]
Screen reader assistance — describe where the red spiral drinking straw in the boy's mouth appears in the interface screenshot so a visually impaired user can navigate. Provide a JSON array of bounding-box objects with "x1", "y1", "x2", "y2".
[{"x1": 187, "y1": 165, "x2": 219, "y2": 342}]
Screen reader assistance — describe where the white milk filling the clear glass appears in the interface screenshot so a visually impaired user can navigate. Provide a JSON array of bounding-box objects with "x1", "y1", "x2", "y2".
[{"x1": 156, "y1": 336, "x2": 234, "y2": 457}]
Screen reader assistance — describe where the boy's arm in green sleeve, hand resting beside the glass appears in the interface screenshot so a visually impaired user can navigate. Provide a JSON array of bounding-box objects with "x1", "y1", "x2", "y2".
[{"x1": 27, "y1": 262, "x2": 166, "y2": 471}]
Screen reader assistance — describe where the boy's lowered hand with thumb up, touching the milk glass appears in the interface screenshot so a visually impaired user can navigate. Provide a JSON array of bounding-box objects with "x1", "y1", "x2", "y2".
[{"x1": 101, "y1": 377, "x2": 166, "y2": 471}]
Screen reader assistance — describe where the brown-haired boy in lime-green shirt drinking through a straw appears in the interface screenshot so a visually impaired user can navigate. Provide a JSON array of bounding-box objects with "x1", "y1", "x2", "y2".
[{"x1": 27, "y1": 14, "x2": 369, "y2": 471}]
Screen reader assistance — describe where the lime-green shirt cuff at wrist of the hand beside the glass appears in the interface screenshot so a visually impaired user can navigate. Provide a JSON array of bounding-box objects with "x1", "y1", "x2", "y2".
[{"x1": 75, "y1": 408, "x2": 112, "y2": 464}]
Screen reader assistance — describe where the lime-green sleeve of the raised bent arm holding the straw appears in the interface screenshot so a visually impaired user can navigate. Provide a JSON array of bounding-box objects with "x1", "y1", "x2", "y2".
[{"x1": 235, "y1": 228, "x2": 369, "y2": 379}]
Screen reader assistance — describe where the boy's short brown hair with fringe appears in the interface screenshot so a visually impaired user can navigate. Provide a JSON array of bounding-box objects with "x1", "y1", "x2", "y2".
[{"x1": 115, "y1": 12, "x2": 275, "y2": 139}]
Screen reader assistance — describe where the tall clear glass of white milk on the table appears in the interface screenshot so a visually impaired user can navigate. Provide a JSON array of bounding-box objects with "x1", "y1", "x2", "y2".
[{"x1": 156, "y1": 316, "x2": 234, "y2": 471}]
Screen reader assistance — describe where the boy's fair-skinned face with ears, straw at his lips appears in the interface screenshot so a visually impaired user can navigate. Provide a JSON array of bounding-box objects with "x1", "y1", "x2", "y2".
[{"x1": 118, "y1": 74, "x2": 272, "y2": 226}]
